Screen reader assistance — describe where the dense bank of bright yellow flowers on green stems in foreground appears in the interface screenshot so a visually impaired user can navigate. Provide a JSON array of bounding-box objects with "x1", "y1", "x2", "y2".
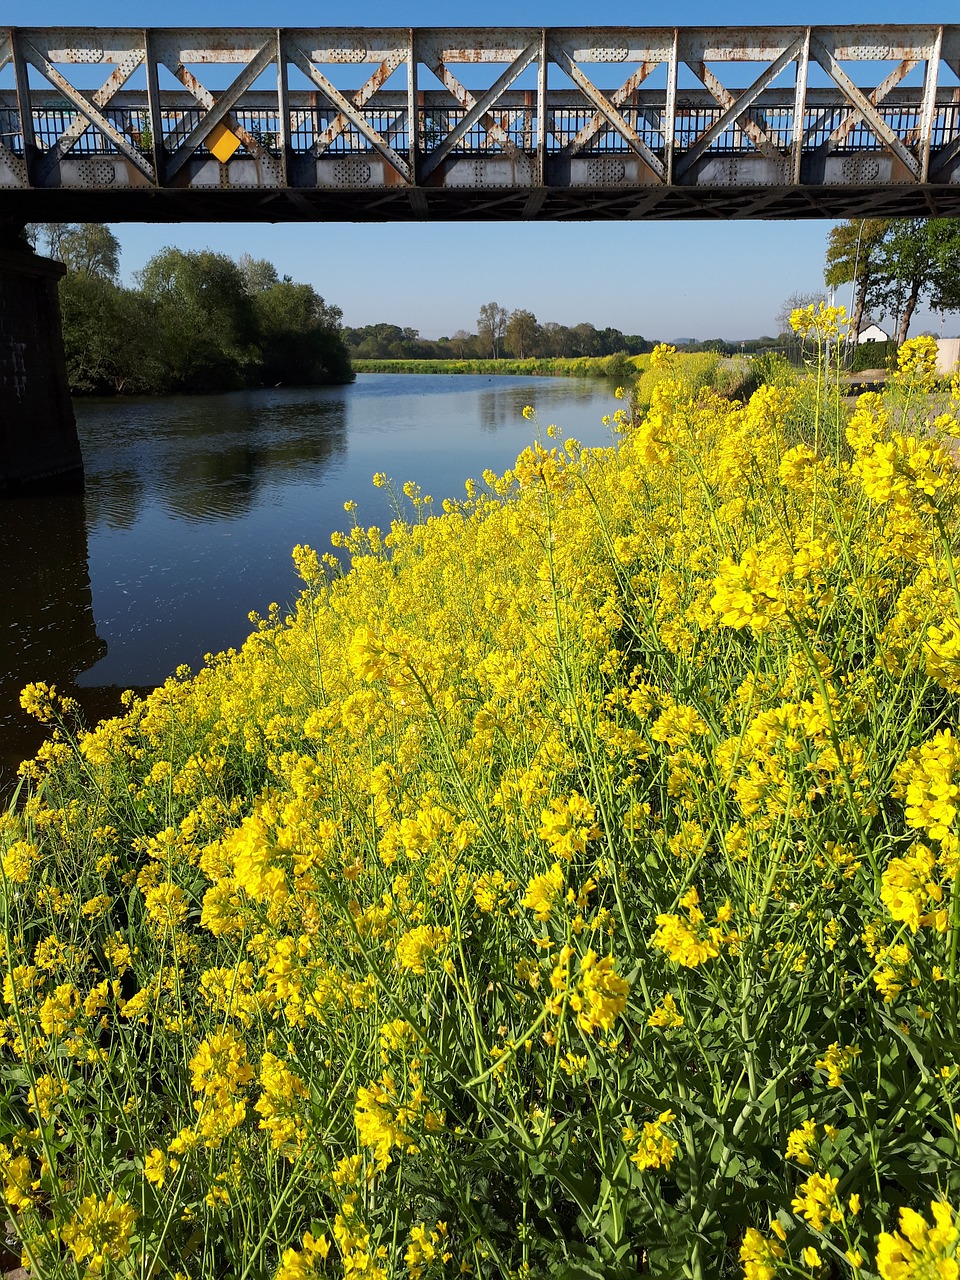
[{"x1": 0, "y1": 307, "x2": 960, "y2": 1280}]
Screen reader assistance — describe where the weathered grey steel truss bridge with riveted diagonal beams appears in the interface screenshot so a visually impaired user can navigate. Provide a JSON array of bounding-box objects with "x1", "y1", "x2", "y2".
[{"x1": 0, "y1": 26, "x2": 960, "y2": 225}]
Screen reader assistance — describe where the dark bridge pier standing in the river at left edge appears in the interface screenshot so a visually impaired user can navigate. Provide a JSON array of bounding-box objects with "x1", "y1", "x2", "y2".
[{"x1": 0, "y1": 238, "x2": 83, "y2": 497}]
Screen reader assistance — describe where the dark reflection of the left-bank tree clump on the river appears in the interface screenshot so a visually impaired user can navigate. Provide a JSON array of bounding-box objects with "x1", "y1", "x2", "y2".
[{"x1": 79, "y1": 389, "x2": 347, "y2": 527}]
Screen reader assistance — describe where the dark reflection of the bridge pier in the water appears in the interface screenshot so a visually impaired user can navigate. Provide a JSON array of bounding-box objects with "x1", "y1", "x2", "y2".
[{"x1": 0, "y1": 497, "x2": 106, "y2": 792}]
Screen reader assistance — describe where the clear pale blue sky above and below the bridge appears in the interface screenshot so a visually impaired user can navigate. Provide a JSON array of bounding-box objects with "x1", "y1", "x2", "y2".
[{"x1": 3, "y1": 0, "x2": 960, "y2": 339}]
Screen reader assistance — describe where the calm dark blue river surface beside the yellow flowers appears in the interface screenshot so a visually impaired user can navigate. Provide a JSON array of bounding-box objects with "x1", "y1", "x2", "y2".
[{"x1": 0, "y1": 374, "x2": 617, "y2": 788}]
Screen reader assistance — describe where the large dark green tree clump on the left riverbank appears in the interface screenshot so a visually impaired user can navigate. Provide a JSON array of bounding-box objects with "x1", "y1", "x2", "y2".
[{"x1": 29, "y1": 223, "x2": 353, "y2": 394}]
